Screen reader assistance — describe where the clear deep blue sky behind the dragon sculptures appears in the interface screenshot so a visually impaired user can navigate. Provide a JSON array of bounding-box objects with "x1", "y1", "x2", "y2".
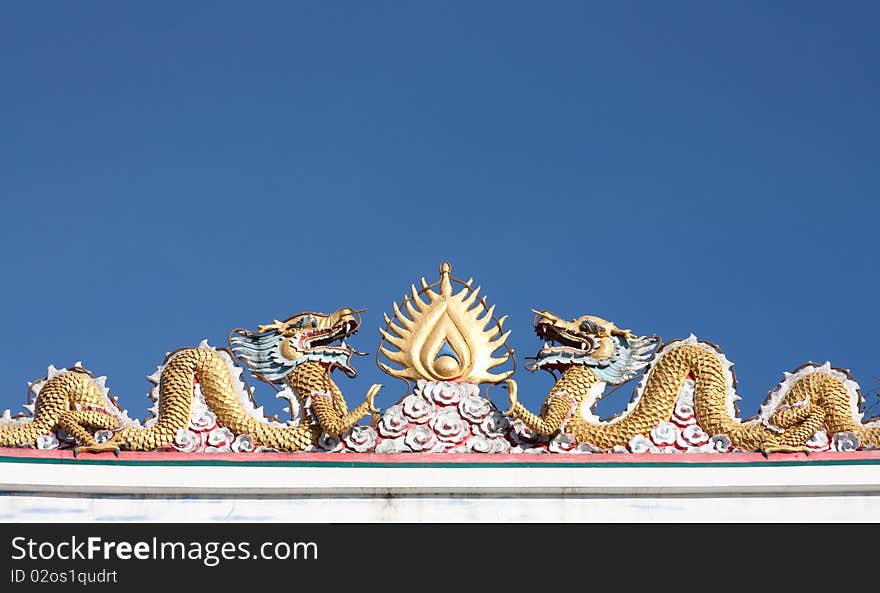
[{"x1": 0, "y1": 1, "x2": 880, "y2": 416}]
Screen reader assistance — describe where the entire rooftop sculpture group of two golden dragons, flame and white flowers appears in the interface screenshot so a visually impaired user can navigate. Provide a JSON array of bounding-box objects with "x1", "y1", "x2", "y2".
[{"x1": 0, "y1": 262, "x2": 880, "y2": 455}]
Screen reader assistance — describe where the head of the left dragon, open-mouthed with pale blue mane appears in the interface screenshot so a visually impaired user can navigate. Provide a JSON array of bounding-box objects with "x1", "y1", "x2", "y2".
[{"x1": 229, "y1": 307, "x2": 361, "y2": 383}]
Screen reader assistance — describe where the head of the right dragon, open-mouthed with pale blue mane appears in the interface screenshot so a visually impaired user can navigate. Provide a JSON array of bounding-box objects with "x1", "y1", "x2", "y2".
[{"x1": 530, "y1": 309, "x2": 659, "y2": 385}]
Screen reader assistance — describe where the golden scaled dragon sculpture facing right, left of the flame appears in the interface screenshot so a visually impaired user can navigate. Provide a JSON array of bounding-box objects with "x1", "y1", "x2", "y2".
[{"x1": 0, "y1": 308, "x2": 381, "y2": 453}]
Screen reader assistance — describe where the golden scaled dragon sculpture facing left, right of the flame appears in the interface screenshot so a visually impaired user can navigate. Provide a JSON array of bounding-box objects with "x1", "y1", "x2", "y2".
[{"x1": 506, "y1": 311, "x2": 880, "y2": 453}]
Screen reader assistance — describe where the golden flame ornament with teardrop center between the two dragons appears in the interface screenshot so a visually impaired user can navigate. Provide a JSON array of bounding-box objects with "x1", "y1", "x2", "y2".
[{"x1": 377, "y1": 262, "x2": 513, "y2": 383}]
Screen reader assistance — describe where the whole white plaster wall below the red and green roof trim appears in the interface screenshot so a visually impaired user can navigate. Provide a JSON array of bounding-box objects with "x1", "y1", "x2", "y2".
[{"x1": 0, "y1": 456, "x2": 880, "y2": 522}]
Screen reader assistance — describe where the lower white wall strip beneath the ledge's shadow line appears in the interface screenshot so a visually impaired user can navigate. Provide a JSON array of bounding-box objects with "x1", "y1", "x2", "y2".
[{"x1": 0, "y1": 494, "x2": 880, "y2": 523}]
